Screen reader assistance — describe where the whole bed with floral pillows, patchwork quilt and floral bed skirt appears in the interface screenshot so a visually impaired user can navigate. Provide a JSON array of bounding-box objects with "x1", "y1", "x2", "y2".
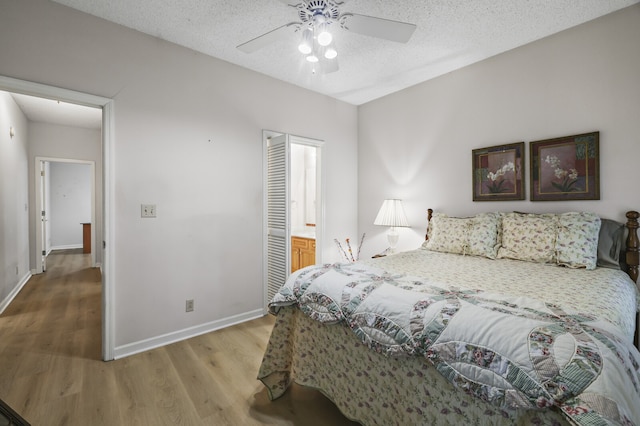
[{"x1": 258, "y1": 210, "x2": 640, "y2": 425}]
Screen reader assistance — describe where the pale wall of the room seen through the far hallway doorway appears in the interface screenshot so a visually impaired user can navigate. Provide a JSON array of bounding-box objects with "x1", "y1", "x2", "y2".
[{"x1": 49, "y1": 162, "x2": 91, "y2": 249}]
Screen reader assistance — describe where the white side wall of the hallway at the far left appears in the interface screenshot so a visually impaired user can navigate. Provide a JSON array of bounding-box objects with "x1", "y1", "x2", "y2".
[{"x1": 0, "y1": 92, "x2": 30, "y2": 312}]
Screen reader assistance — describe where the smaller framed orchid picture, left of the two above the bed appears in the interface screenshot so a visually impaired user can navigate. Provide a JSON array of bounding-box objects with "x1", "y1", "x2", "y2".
[{"x1": 472, "y1": 142, "x2": 524, "y2": 201}]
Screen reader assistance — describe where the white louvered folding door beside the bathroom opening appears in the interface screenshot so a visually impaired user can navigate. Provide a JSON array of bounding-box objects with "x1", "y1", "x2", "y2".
[{"x1": 267, "y1": 135, "x2": 290, "y2": 300}]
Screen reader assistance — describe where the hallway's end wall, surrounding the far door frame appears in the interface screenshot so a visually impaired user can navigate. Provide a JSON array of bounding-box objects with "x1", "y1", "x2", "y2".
[{"x1": 29, "y1": 122, "x2": 103, "y2": 267}]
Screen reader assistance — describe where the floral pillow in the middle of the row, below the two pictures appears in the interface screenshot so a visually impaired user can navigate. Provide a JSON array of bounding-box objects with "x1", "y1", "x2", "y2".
[{"x1": 498, "y1": 213, "x2": 559, "y2": 263}]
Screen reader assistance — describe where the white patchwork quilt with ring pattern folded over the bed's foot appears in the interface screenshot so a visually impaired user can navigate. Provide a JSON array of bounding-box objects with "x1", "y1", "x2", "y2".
[{"x1": 270, "y1": 264, "x2": 640, "y2": 425}]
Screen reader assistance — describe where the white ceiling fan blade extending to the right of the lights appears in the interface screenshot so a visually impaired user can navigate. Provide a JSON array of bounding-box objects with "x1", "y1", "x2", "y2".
[{"x1": 340, "y1": 13, "x2": 416, "y2": 43}]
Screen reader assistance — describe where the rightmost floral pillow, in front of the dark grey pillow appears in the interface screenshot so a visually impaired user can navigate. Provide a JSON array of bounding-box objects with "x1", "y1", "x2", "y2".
[{"x1": 556, "y1": 212, "x2": 600, "y2": 269}]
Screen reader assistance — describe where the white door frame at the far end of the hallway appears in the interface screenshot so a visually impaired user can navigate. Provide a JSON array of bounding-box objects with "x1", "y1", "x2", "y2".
[{"x1": 33, "y1": 157, "x2": 96, "y2": 274}]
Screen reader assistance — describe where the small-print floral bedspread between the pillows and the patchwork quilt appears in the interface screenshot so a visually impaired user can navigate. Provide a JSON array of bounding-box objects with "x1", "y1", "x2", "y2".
[{"x1": 360, "y1": 249, "x2": 640, "y2": 341}]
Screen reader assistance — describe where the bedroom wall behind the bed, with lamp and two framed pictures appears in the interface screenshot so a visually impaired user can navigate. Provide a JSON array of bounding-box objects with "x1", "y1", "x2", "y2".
[{"x1": 358, "y1": 5, "x2": 640, "y2": 255}]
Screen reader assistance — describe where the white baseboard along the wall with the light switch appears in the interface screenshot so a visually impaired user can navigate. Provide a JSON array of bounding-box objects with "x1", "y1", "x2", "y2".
[{"x1": 113, "y1": 309, "x2": 264, "y2": 359}]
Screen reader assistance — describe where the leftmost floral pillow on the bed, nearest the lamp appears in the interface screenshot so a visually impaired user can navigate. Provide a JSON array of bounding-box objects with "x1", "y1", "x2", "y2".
[{"x1": 423, "y1": 213, "x2": 500, "y2": 259}]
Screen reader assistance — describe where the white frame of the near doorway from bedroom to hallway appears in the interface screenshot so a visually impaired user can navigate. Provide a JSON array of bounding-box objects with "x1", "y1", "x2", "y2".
[{"x1": 0, "y1": 75, "x2": 115, "y2": 361}]
